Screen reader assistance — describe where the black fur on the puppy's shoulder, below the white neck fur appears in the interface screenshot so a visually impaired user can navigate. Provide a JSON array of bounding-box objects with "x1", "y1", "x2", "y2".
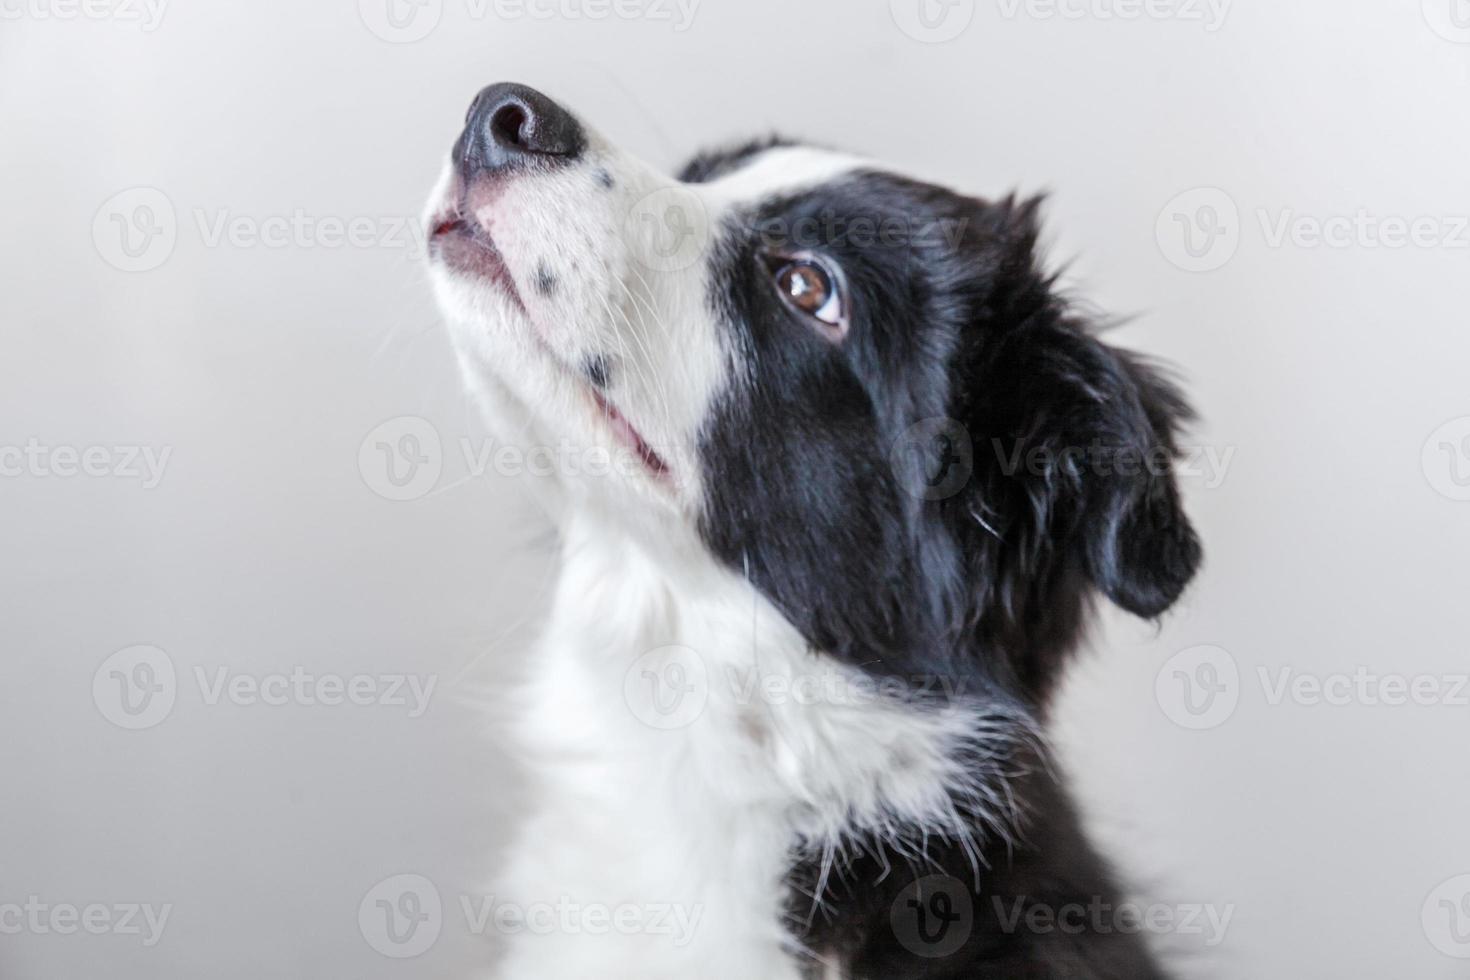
[{"x1": 788, "y1": 768, "x2": 1166, "y2": 980}]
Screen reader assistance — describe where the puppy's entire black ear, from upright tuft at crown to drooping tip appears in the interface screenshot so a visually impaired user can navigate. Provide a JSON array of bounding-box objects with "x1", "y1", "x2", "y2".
[{"x1": 964, "y1": 198, "x2": 1201, "y2": 619}]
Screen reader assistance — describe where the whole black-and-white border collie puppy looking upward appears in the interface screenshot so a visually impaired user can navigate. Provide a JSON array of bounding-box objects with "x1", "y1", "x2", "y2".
[{"x1": 428, "y1": 84, "x2": 1200, "y2": 980}]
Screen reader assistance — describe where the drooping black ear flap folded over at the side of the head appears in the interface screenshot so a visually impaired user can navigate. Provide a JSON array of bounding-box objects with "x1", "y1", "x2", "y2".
[{"x1": 976, "y1": 326, "x2": 1201, "y2": 619}]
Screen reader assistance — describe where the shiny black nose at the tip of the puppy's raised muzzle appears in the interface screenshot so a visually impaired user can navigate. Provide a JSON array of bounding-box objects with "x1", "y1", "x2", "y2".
[{"x1": 454, "y1": 82, "x2": 587, "y2": 173}]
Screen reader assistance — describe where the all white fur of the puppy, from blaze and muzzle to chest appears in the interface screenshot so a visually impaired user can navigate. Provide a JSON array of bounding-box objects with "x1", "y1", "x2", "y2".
[{"x1": 431, "y1": 128, "x2": 1010, "y2": 980}]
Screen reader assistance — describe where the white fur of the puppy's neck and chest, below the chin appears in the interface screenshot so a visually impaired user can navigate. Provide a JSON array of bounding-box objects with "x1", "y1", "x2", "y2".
[{"x1": 497, "y1": 519, "x2": 1003, "y2": 980}]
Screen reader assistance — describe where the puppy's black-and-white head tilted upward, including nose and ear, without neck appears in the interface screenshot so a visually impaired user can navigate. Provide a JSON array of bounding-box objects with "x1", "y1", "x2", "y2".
[{"x1": 429, "y1": 84, "x2": 1200, "y2": 702}]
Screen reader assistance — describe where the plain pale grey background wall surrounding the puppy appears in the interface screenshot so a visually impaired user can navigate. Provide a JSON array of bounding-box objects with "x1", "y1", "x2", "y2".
[{"x1": 0, "y1": 0, "x2": 1470, "y2": 980}]
